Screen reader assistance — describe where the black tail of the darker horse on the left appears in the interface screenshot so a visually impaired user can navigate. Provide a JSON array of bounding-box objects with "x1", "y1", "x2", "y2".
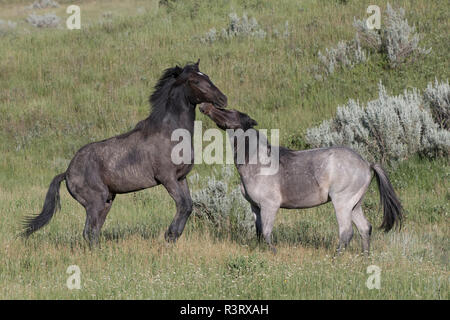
[{"x1": 22, "y1": 172, "x2": 66, "y2": 237}]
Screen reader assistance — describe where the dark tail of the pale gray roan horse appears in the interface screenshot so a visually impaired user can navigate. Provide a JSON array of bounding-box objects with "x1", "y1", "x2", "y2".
[{"x1": 371, "y1": 164, "x2": 403, "y2": 232}]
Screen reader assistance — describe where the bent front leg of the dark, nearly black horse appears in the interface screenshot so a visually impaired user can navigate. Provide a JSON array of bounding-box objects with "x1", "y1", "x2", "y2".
[{"x1": 163, "y1": 179, "x2": 192, "y2": 242}]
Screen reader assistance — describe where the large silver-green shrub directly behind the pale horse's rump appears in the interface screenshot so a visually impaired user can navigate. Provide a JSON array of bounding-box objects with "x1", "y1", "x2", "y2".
[{"x1": 306, "y1": 83, "x2": 450, "y2": 162}]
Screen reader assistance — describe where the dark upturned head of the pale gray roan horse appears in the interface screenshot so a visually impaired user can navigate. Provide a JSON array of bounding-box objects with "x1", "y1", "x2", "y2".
[{"x1": 199, "y1": 103, "x2": 258, "y2": 131}]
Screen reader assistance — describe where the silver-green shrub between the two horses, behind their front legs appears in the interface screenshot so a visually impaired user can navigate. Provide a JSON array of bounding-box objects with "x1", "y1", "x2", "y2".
[{"x1": 192, "y1": 166, "x2": 255, "y2": 240}]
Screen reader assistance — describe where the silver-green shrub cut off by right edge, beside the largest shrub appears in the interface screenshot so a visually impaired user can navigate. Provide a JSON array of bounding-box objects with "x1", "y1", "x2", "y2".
[{"x1": 423, "y1": 79, "x2": 450, "y2": 130}]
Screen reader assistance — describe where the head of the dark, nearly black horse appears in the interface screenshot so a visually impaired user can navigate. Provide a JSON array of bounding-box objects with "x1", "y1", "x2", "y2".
[{"x1": 177, "y1": 59, "x2": 228, "y2": 108}]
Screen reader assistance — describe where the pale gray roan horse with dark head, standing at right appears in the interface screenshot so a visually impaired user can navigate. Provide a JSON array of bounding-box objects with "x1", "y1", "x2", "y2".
[{"x1": 200, "y1": 104, "x2": 403, "y2": 253}]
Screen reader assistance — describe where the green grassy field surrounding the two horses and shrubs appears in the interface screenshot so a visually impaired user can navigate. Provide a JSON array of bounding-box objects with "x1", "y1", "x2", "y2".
[{"x1": 0, "y1": 0, "x2": 450, "y2": 299}]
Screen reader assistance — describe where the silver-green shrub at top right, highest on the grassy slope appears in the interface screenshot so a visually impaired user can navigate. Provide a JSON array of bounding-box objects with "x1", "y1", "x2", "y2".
[{"x1": 353, "y1": 3, "x2": 431, "y2": 68}]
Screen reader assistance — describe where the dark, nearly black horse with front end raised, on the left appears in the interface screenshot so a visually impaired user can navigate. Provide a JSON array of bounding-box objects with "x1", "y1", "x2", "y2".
[{"x1": 23, "y1": 60, "x2": 227, "y2": 245}]
